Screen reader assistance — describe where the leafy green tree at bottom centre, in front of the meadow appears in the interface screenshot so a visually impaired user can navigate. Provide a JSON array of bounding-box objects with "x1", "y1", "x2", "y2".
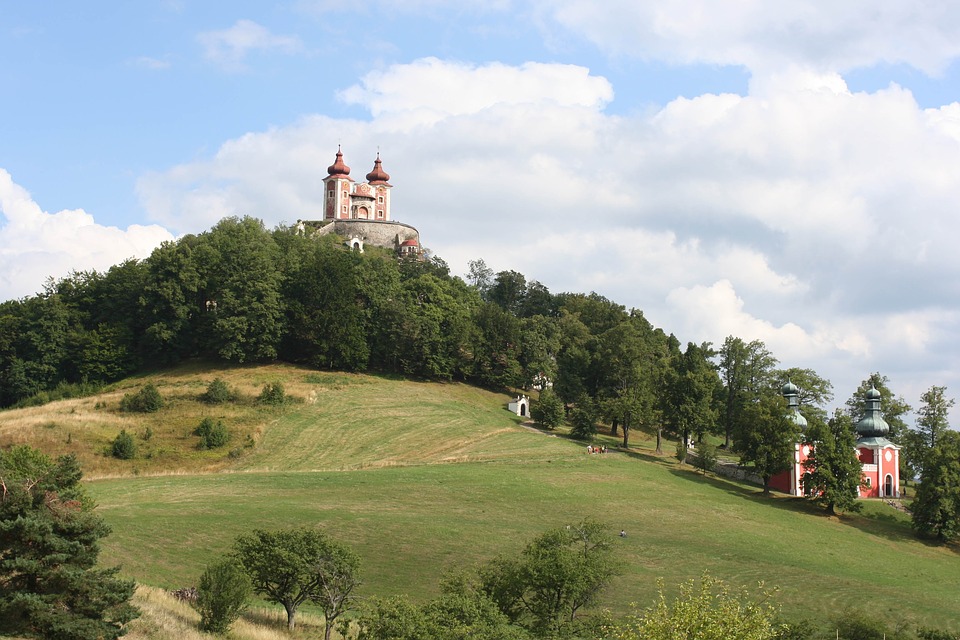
[{"x1": 480, "y1": 520, "x2": 616, "y2": 636}]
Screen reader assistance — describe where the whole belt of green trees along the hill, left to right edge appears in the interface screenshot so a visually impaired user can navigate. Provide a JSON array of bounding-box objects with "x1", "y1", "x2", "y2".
[{"x1": 0, "y1": 217, "x2": 960, "y2": 539}]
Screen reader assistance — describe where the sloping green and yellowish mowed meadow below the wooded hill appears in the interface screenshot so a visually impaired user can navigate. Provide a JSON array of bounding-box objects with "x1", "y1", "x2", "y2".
[{"x1": 0, "y1": 363, "x2": 960, "y2": 632}]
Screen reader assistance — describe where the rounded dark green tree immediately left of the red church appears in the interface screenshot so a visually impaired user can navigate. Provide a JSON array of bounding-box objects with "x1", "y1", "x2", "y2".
[{"x1": 734, "y1": 393, "x2": 800, "y2": 495}]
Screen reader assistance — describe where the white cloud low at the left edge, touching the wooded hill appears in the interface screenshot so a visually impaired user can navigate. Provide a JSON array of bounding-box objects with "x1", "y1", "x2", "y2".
[{"x1": 0, "y1": 169, "x2": 173, "y2": 300}]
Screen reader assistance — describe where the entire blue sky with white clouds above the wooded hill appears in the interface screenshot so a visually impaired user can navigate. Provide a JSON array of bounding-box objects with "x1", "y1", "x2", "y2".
[{"x1": 0, "y1": 0, "x2": 960, "y2": 420}]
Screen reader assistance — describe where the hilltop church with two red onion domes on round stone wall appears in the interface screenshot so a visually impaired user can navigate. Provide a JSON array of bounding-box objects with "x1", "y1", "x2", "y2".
[{"x1": 297, "y1": 147, "x2": 421, "y2": 256}]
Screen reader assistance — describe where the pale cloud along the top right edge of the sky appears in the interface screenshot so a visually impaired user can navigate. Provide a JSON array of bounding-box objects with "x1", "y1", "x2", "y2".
[{"x1": 534, "y1": 0, "x2": 960, "y2": 74}]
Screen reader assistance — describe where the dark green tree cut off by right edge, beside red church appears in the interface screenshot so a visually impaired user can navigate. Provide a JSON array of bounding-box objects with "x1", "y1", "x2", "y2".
[{"x1": 910, "y1": 431, "x2": 960, "y2": 541}]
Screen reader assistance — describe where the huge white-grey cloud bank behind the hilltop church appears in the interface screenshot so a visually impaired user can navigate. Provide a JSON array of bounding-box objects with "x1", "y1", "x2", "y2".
[{"x1": 138, "y1": 58, "x2": 960, "y2": 410}]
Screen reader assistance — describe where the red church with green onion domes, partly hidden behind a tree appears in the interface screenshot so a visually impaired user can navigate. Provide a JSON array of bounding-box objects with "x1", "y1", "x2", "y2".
[{"x1": 770, "y1": 381, "x2": 900, "y2": 498}]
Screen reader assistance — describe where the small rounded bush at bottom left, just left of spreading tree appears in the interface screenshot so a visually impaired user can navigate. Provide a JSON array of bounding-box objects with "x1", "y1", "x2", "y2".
[{"x1": 196, "y1": 559, "x2": 253, "y2": 633}]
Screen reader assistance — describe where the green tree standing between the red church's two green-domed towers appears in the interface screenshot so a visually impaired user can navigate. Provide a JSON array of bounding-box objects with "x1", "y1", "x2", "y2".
[{"x1": 803, "y1": 409, "x2": 863, "y2": 515}]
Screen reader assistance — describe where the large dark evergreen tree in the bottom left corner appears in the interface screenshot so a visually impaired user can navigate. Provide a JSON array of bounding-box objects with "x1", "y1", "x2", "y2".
[{"x1": 0, "y1": 446, "x2": 138, "y2": 640}]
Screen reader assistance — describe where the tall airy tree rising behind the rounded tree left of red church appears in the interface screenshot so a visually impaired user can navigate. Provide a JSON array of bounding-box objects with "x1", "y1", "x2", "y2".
[{"x1": 719, "y1": 336, "x2": 777, "y2": 447}]
